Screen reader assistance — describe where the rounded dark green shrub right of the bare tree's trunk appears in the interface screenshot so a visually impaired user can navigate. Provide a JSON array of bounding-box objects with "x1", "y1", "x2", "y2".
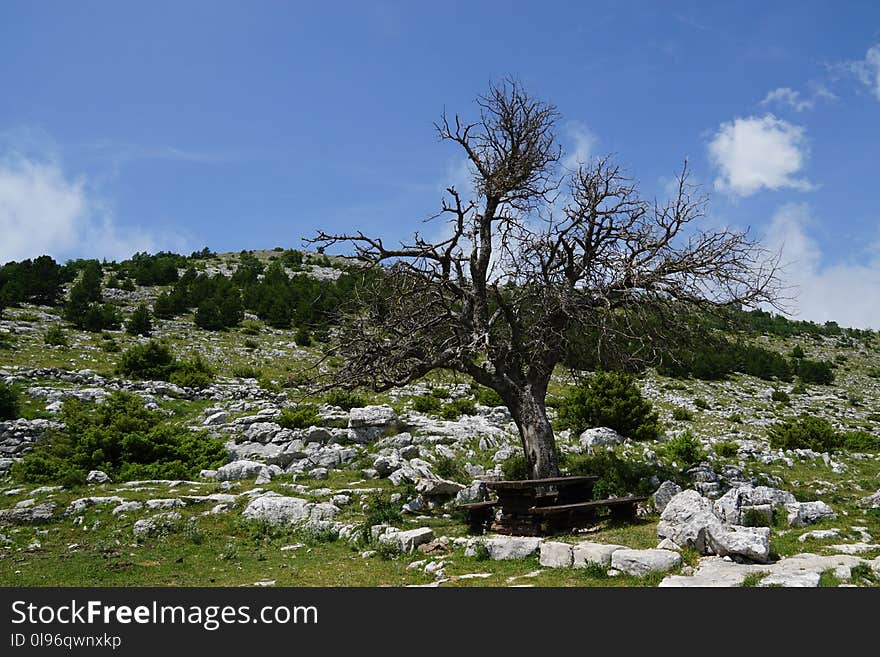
[{"x1": 558, "y1": 372, "x2": 660, "y2": 440}]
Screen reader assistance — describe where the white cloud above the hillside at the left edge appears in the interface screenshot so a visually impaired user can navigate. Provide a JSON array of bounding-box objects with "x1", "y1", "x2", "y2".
[{"x1": 0, "y1": 155, "x2": 188, "y2": 263}]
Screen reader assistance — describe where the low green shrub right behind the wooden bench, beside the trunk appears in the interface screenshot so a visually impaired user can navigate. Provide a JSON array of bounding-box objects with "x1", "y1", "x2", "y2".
[{"x1": 567, "y1": 450, "x2": 681, "y2": 500}]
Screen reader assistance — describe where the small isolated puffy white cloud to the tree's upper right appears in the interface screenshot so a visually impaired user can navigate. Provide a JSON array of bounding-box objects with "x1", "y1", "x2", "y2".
[{"x1": 709, "y1": 114, "x2": 812, "y2": 196}]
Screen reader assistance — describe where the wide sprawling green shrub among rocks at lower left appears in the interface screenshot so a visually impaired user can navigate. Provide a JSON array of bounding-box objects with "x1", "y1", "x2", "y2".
[{"x1": 12, "y1": 392, "x2": 227, "y2": 486}]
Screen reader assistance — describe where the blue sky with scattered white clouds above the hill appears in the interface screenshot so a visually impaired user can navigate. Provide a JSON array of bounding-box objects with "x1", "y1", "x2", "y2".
[{"x1": 0, "y1": 0, "x2": 880, "y2": 328}]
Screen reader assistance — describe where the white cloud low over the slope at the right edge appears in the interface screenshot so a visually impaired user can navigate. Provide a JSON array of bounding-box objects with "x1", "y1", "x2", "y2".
[{"x1": 765, "y1": 203, "x2": 880, "y2": 329}]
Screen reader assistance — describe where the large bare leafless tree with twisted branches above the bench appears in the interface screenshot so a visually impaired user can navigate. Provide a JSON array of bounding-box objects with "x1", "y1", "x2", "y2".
[{"x1": 310, "y1": 80, "x2": 778, "y2": 477}]
